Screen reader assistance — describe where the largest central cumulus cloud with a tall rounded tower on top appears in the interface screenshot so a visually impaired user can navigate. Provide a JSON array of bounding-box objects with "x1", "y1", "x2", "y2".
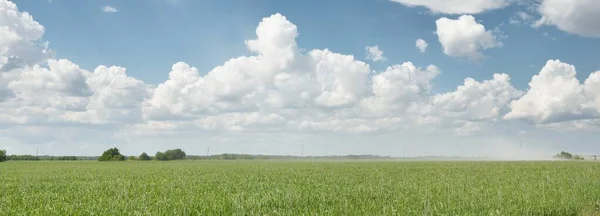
[{"x1": 137, "y1": 14, "x2": 440, "y2": 133}]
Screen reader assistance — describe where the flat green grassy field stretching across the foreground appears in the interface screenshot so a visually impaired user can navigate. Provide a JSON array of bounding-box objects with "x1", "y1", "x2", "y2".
[{"x1": 0, "y1": 161, "x2": 600, "y2": 215}]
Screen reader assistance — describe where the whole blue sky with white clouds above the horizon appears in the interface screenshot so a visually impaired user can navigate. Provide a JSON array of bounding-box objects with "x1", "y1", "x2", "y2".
[{"x1": 0, "y1": 0, "x2": 600, "y2": 159}]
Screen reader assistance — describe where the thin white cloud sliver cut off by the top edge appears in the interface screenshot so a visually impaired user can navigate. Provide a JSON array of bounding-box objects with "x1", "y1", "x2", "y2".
[{"x1": 391, "y1": 0, "x2": 510, "y2": 14}]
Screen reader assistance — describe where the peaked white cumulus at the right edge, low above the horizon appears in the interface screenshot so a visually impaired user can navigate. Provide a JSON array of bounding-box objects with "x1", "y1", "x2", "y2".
[{"x1": 504, "y1": 60, "x2": 600, "y2": 124}]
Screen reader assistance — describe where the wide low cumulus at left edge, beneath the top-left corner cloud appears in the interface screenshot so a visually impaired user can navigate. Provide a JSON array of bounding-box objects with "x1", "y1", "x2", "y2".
[{"x1": 0, "y1": 59, "x2": 149, "y2": 125}]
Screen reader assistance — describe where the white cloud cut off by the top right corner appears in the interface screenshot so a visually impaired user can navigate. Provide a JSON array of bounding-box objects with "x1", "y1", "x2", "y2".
[{"x1": 534, "y1": 0, "x2": 600, "y2": 37}]
